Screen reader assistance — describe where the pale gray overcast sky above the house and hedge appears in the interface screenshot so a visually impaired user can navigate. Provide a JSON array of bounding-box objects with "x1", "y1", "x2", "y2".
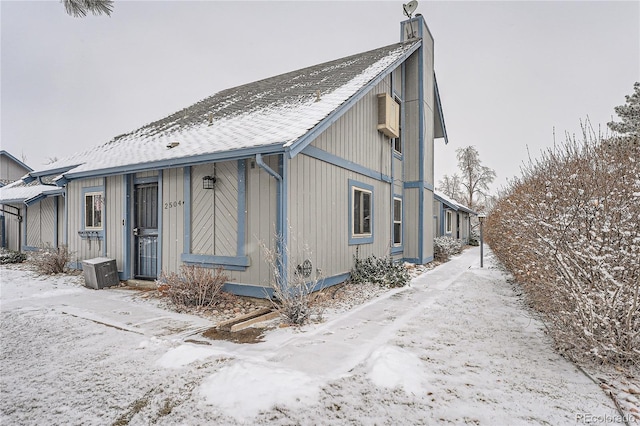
[{"x1": 0, "y1": 0, "x2": 640, "y2": 193}]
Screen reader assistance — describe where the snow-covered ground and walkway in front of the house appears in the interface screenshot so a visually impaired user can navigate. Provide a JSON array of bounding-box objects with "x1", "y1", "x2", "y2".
[{"x1": 0, "y1": 248, "x2": 637, "y2": 425}]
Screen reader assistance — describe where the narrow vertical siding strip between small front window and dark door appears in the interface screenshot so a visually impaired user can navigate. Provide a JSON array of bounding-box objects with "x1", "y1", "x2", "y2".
[{"x1": 104, "y1": 175, "x2": 125, "y2": 272}]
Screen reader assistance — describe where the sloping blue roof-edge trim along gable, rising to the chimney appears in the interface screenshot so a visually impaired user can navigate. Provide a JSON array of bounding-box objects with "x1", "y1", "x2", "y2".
[{"x1": 286, "y1": 40, "x2": 422, "y2": 158}]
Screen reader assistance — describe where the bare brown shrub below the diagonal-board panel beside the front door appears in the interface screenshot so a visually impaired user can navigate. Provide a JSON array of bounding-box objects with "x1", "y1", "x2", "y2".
[{"x1": 158, "y1": 265, "x2": 229, "y2": 307}]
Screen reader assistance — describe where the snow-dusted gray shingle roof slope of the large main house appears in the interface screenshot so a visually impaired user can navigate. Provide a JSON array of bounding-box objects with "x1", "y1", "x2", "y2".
[{"x1": 38, "y1": 40, "x2": 420, "y2": 179}]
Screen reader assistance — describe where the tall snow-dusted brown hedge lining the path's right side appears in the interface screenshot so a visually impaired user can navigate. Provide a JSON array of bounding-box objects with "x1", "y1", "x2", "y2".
[{"x1": 485, "y1": 134, "x2": 640, "y2": 363}]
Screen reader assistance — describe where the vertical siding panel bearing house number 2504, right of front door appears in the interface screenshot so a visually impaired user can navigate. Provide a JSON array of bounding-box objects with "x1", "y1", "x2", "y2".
[{"x1": 158, "y1": 168, "x2": 185, "y2": 272}]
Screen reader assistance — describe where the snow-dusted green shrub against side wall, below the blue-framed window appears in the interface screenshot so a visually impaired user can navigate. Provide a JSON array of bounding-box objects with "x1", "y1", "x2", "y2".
[{"x1": 351, "y1": 255, "x2": 411, "y2": 288}]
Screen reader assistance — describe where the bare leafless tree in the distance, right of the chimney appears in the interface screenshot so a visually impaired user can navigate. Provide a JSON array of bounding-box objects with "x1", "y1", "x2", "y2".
[{"x1": 456, "y1": 146, "x2": 496, "y2": 209}]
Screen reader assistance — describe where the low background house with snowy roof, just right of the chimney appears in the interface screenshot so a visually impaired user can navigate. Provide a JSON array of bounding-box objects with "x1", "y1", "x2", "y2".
[{"x1": 433, "y1": 191, "x2": 478, "y2": 244}]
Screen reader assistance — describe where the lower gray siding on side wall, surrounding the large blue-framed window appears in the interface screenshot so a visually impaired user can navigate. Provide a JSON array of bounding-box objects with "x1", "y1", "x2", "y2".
[{"x1": 288, "y1": 155, "x2": 391, "y2": 277}]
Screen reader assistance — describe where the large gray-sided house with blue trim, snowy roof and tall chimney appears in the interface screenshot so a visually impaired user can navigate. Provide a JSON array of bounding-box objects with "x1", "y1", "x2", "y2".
[{"x1": 13, "y1": 15, "x2": 446, "y2": 297}]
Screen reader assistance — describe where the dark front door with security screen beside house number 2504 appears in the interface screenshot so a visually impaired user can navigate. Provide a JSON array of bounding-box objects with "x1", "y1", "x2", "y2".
[{"x1": 133, "y1": 182, "x2": 158, "y2": 280}]
